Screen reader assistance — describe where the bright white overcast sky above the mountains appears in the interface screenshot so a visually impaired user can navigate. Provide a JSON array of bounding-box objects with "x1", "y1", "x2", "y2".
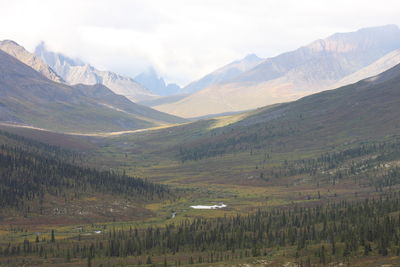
[{"x1": 0, "y1": 0, "x2": 400, "y2": 85}]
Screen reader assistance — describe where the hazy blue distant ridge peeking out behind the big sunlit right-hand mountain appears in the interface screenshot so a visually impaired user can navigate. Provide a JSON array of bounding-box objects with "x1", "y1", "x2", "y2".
[{"x1": 183, "y1": 54, "x2": 263, "y2": 94}]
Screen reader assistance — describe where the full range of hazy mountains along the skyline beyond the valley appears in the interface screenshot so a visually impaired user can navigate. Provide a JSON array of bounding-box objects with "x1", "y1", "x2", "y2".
[{"x1": 0, "y1": 25, "x2": 400, "y2": 132}]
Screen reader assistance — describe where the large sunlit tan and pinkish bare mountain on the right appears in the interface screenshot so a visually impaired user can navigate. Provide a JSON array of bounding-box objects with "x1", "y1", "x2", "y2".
[{"x1": 155, "y1": 25, "x2": 400, "y2": 117}]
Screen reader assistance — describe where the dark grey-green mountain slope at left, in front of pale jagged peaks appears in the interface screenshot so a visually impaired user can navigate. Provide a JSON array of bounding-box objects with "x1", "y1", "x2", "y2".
[{"x1": 0, "y1": 45, "x2": 182, "y2": 132}]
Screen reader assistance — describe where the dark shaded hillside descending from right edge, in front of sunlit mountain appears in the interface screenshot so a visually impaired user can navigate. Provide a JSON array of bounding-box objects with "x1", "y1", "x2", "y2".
[{"x1": 175, "y1": 64, "x2": 400, "y2": 160}]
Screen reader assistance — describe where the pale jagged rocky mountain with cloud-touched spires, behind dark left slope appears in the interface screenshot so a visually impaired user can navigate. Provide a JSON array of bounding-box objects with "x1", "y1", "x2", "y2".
[{"x1": 34, "y1": 42, "x2": 158, "y2": 102}]
